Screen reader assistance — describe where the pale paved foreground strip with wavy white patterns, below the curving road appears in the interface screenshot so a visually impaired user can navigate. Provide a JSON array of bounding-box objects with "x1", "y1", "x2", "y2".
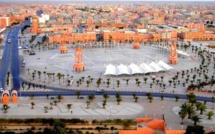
[{"x1": 0, "y1": 96, "x2": 215, "y2": 130}]
